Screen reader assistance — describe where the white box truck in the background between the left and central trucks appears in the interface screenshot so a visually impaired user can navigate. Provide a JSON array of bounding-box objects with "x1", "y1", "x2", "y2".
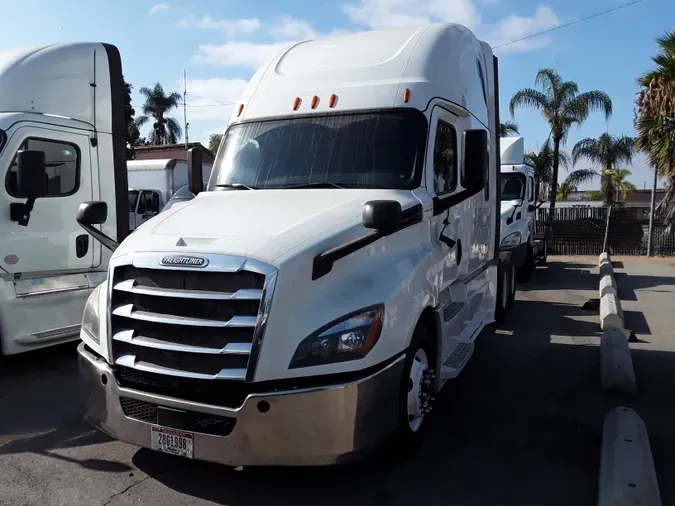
[{"x1": 127, "y1": 158, "x2": 212, "y2": 230}]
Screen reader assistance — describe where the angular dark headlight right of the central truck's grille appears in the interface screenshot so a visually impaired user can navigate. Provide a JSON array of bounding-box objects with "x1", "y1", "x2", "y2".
[{"x1": 289, "y1": 305, "x2": 384, "y2": 369}]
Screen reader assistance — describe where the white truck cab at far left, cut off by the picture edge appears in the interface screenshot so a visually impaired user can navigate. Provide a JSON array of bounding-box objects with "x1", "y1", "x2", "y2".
[{"x1": 0, "y1": 43, "x2": 127, "y2": 355}]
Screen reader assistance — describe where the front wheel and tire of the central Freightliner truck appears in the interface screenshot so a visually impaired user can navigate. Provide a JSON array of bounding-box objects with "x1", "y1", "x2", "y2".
[{"x1": 390, "y1": 321, "x2": 436, "y2": 458}]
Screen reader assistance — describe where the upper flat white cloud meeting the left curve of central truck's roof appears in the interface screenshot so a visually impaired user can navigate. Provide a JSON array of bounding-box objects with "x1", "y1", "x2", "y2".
[{"x1": 192, "y1": 40, "x2": 295, "y2": 70}]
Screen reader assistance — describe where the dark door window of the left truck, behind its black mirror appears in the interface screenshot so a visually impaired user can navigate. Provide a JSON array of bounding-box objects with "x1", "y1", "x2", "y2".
[{"x1": 5, "y1": 137, "x2": 80, "y2": 198}]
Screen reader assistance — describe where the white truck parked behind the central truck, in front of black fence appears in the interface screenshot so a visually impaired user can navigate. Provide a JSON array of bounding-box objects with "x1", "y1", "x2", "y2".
[{"x1": 500, "y1": 137, "x2": 548, "y2": 282}]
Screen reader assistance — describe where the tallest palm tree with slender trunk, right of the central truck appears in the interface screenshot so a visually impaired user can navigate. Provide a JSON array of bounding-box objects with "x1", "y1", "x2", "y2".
[{"x1": 509, "y1": 68, "x2": 612, "y2": 220}]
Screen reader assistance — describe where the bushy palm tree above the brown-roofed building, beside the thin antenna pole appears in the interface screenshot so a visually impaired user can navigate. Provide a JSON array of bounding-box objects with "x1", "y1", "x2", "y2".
[{"x1": 136, "y1": 83, "x2": 182, "y2": 145}]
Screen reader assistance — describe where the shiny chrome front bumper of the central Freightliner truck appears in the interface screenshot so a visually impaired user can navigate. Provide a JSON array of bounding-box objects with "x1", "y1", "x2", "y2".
[{"x1": 78, "y1": 344, "x2": 403, "y2": 466}]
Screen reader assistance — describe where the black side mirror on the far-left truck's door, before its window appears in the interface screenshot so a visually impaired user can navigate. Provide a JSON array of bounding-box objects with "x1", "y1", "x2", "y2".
[{"x1": 9, "y1": 149, "x2": 47, "y2": 227}]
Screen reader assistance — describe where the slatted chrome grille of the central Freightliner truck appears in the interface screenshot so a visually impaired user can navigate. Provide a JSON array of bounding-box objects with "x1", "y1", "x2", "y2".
[{"x1": 110, "y1": 255, "x2": 276, "y2": 392}]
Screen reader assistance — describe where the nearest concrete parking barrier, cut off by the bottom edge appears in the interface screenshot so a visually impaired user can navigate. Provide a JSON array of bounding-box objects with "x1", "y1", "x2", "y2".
[{"x1": 598, "y1": 407, "x2": 662, "y2": 506}]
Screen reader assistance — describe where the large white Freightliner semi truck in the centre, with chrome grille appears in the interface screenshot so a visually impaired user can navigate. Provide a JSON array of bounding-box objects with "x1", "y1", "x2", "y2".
[{"x1": 70, "y1": 24, "x2": 509, "y2": 465}]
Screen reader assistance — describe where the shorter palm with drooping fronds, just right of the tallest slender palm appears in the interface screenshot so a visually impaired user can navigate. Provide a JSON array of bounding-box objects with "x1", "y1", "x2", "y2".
[{"x1": 572, "y1": 133, "x2": 635, "y2": 208}]
